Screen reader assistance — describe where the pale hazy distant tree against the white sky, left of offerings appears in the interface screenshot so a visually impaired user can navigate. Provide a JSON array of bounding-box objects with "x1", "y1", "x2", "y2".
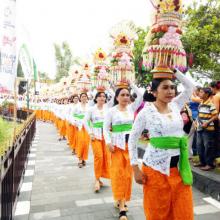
[{"x1": 54, "y1": 42, "x2": 77, "y2": 82}]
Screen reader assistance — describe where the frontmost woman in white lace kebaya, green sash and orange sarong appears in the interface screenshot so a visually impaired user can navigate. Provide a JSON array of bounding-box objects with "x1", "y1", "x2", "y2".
[{"x1": 129, "y1": 71, "x2": 194, "y2": 220}]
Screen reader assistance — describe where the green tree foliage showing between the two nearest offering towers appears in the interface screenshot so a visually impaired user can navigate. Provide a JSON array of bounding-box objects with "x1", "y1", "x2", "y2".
[{"x1": 133, "y1": 27, "x2": 152, "y2": 86}]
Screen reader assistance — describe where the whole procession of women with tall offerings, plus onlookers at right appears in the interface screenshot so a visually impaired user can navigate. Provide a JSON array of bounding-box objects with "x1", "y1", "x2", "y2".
[{"x1": 11, "y1": 1, "x2": 220, "y2": 220}]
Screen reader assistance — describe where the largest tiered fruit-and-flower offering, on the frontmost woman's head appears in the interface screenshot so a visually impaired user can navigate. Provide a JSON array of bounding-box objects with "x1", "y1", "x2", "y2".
[{"x1": 143, "y1": 0, "x2": 188, "y2": 78}]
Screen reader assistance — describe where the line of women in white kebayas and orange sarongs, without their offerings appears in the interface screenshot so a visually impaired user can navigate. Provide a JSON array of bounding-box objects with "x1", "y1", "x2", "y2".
[{"x1": 32, "y1": 72, "x2": 194, "y2": 220}]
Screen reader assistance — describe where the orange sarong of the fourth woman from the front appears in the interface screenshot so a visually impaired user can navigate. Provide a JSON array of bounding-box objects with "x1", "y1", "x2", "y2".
[{"x1": 76, "y1": 127, "x2": 90, "y2": 160}]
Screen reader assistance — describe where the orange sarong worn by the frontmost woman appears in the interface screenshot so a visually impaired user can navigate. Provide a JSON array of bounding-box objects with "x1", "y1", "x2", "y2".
[{"x1": 142, "y1": 166, "x2": 193, "y2": 220}]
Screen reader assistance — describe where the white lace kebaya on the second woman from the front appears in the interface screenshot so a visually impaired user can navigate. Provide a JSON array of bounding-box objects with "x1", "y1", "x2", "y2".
[{"x1": 103, "y1": 85, "x2": 143, "y2": 150}]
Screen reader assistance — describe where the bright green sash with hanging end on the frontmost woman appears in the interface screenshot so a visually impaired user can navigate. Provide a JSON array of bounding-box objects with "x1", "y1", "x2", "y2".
[{"x1": 150, "y1": 137, "x2": 193, "y2": 185}]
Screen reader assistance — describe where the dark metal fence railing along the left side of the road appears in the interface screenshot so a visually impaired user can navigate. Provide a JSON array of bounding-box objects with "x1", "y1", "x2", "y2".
[{"x1": 0, "y1": 113, "x2": 36, "y2": 220}]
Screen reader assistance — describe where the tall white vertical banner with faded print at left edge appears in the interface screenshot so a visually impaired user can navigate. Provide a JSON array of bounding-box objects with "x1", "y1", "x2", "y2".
[{"x1": 0, "y1": 0, "x2": 17, "y2": 91}]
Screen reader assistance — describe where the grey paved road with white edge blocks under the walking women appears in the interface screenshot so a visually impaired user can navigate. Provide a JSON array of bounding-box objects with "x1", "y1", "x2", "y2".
[{"x1": 15, "y1": 122, "x2": 220, "y2": 220}]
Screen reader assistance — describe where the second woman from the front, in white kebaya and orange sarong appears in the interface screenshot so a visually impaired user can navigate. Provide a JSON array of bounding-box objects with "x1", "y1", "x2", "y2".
[{"x1": 104, "y1": 85, "x2": 142, "y2": 220}]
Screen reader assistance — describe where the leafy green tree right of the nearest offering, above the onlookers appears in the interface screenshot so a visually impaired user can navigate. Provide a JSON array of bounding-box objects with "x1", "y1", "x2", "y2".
[{"x1": 182, "y1": 0, "x2": 220, "y2": 79}]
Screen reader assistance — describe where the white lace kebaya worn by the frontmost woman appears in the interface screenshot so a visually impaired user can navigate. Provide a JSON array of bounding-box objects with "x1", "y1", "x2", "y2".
[{"x1": 128, "y1": 72, "x2": 195, "y2": 175}]
